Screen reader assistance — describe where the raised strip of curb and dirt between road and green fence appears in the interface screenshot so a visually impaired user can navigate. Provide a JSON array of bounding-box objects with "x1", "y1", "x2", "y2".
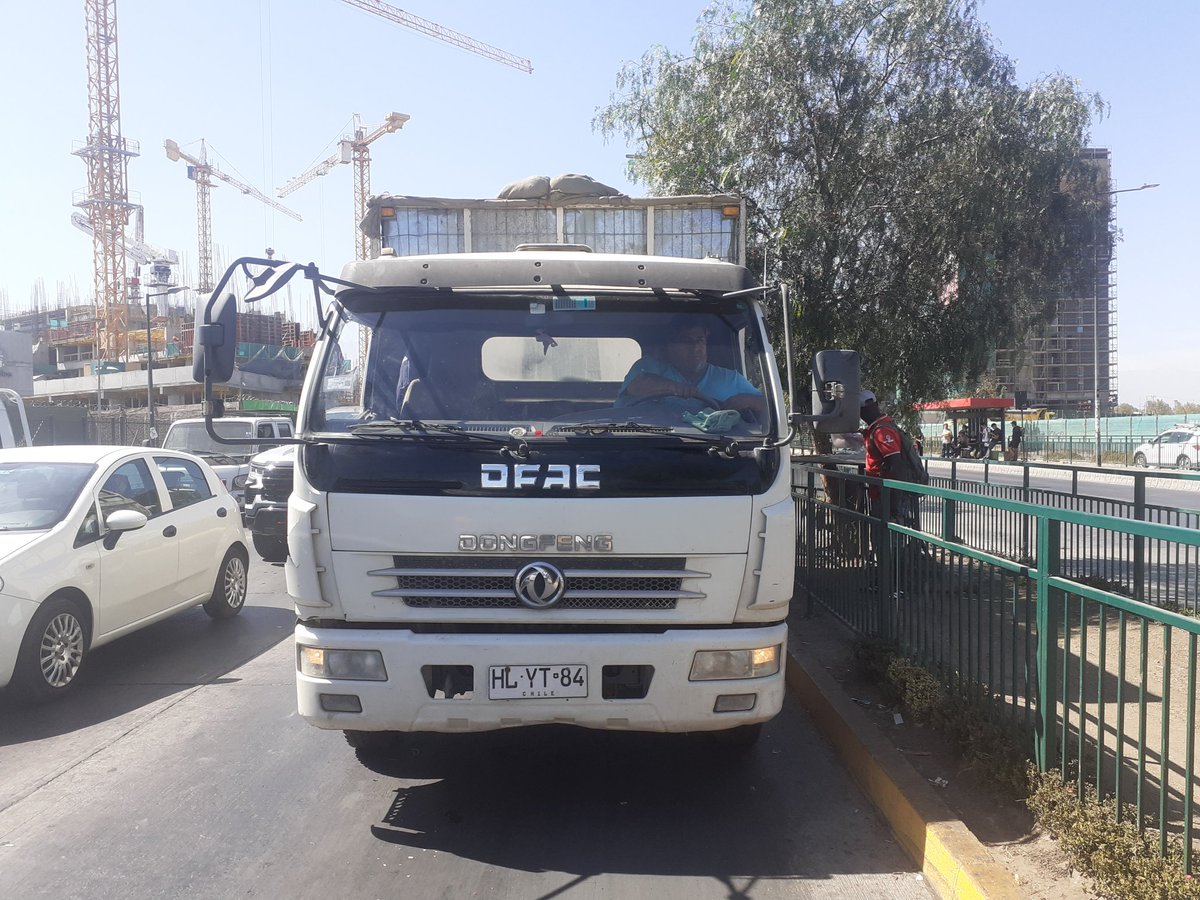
[{"x1": 787, "y1": 599, "x2": 1088, "y2": 900}]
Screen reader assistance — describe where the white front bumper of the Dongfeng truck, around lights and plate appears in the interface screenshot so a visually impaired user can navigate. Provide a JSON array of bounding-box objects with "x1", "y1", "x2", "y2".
[{"x1": 295, "y1": 624, "x2": 787, "y2": 732}]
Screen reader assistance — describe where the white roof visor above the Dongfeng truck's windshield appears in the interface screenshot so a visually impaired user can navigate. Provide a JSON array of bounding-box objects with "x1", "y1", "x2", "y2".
[{"x1": 342, "y1": 245, "x2": 754, "y2": 293}]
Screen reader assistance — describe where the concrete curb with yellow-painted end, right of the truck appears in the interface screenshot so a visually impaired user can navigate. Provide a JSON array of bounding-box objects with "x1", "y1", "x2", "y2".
[{"x1": 786, "y1": 650, "x2": 1021, "y2": 900}]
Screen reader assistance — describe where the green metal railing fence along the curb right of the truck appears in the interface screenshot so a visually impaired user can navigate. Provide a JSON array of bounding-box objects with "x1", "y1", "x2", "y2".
[{"x1": 794, "y1": 466, "x2": 1200, "y2": 872}]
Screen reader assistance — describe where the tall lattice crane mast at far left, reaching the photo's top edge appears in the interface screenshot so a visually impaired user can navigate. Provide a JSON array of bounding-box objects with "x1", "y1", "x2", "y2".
[{"x1": 74, "y1": 0, "x2": 138, "y2": 372}]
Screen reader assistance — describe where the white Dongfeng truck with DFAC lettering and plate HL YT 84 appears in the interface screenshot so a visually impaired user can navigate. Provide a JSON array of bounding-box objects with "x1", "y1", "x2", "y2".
[{"x1": 194, "y1": 190, "x2": 858, "y2": 750}]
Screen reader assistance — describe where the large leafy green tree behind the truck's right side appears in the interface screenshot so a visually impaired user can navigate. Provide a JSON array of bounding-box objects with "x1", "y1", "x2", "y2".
[{"x1": 595, "y1": 0, "x2": 1108, "y2": 412}]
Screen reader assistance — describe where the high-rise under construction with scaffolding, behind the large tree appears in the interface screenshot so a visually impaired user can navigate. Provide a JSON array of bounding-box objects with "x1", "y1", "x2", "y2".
[{"x1": 995, "y1": 148, "x2": 1117, "y2": 418}]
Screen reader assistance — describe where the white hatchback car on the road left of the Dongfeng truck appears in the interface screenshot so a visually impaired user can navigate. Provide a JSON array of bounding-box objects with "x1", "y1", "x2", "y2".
[{"x1": 0, "y1": 446, "x2": 250, "y2": 700}]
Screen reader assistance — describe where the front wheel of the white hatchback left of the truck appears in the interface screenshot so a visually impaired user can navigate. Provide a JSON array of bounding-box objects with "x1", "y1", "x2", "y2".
[{"x1": 12, "y1": 598, "x2": 91, "y2": 703}]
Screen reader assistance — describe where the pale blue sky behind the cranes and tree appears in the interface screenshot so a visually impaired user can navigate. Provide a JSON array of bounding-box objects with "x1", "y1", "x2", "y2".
[{"x1": 0, "y1": 0, "x2": 1200, "y2": 406}]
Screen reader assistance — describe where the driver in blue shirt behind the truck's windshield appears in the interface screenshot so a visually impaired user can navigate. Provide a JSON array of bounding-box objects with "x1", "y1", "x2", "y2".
[{"x1": 616, "y1": 316, "x2": 767, "y2": 415}]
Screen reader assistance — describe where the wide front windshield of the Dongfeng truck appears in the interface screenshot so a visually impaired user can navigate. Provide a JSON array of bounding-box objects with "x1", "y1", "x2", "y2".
[{"x1": 307, "y1": 292, "x2": 776, "y2": 440}]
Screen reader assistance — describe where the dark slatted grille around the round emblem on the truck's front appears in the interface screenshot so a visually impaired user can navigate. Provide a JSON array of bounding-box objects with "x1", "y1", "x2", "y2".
[{"x1": 370, "y1": 556, "x2": 709, "y2": 610}]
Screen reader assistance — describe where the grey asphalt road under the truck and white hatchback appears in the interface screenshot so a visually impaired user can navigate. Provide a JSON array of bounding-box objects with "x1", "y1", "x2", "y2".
[{"x1": 0, "y1": 562, "x2": 930, "y2": 900}]
